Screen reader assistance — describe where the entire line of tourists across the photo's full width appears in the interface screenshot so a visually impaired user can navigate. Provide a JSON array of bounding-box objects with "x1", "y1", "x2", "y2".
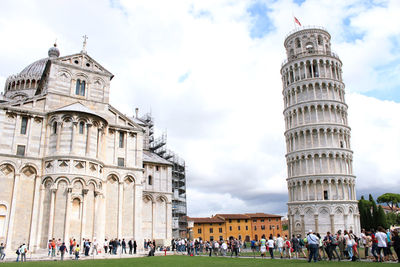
[{"x1": 0, "y1": 227, "x2": 400, "y2": 263}]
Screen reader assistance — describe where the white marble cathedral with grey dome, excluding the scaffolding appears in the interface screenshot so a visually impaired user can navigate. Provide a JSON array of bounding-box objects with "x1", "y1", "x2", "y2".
[{"x1": 0, "y1": 45, "x2": 173, "y2": 251}]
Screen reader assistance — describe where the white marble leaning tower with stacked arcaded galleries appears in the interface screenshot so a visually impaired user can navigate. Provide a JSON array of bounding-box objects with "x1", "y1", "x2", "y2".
[{"x1": 281, "y1": 27, "x2": 360, "y2": 235}]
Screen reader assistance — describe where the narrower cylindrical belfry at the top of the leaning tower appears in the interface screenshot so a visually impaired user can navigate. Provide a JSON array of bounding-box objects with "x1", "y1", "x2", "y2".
[{"x1": 284, "y1": 26, "x2": 332, "y2": 61}]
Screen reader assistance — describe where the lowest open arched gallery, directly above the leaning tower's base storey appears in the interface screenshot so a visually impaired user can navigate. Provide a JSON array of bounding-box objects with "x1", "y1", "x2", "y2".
[{"x1": 288, "y1": 178, "x2": 356, "y2": 202}]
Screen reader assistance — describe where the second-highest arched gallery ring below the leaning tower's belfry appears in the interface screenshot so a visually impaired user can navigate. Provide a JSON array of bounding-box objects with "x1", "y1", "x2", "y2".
[{"x1": 283, "y1": 81, "x2": 345, "y2": 108}]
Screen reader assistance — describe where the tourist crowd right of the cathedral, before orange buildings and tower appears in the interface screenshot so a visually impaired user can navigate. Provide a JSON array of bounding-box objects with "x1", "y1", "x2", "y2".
[{"x1": 171, "y1": 227, "x2": 400, "y2": 263}]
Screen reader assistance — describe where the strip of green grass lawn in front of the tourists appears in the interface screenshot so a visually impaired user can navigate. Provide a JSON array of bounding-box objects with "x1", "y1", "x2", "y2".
[{"x1": 0, "y1": 256, "x2": 388, "y2": 267}]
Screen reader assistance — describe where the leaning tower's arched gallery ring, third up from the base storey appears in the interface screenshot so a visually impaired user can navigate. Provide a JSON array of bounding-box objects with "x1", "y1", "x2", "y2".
[{"x1": 285, "y1": 126, "x2": 350, "y2": 153}]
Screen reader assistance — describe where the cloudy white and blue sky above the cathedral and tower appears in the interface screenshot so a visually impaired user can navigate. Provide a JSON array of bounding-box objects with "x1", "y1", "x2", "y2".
[{"x1": 0, "y1": 0, "x2": 400, "y2": 216}]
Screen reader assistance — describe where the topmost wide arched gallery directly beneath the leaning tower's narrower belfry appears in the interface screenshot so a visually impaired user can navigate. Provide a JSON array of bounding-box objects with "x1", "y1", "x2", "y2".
[{"x1": 281, "y1": 58, "x2": 343, "y2": 86}]
